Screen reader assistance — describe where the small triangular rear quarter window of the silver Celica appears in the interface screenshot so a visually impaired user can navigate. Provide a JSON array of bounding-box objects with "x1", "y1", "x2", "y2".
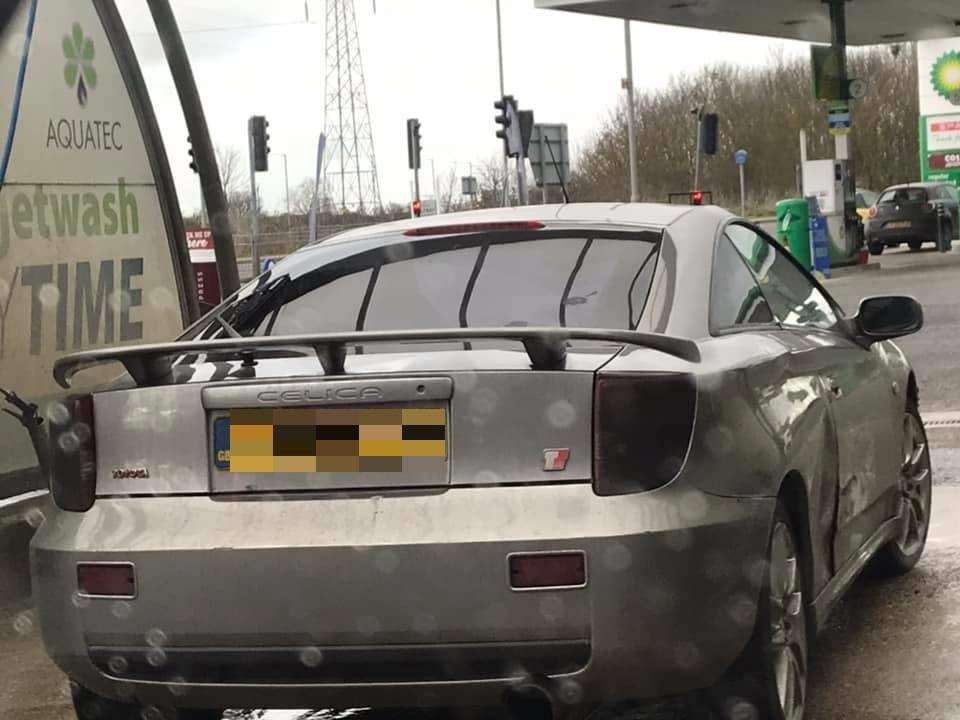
[{"x1": 710, "y1": 237, "x2": 774, "y2": 331}]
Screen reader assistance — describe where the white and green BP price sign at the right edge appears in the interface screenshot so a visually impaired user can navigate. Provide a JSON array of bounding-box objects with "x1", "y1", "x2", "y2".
[{"x1": 917, "y1": 38, "x2": 960, "y2": 187}]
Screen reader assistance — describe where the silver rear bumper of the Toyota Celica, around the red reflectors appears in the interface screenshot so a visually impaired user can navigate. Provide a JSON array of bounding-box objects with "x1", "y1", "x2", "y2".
[{"x1": 31, "y1": 485, "x2": 773, "y2": 707}]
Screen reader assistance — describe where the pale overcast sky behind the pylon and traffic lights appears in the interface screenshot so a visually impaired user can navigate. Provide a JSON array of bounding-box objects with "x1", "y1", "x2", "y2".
[{"x1": 117, "y1": 0, "x2": 807, "y2": 213}]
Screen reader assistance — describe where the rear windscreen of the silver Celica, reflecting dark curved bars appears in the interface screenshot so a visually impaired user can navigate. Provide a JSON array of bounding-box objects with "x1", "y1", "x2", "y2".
[{"x1": 210, "y1": 233, "x2": 659, "y2": 335}]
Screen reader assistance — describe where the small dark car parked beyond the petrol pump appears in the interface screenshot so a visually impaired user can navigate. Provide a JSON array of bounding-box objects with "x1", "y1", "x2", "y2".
[{"x1": 866, "y1": 183, "x2": 960, "y2": 255}]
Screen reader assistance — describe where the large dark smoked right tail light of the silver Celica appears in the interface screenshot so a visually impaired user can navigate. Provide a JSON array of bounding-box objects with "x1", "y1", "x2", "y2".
[{"x1": 593, "y1": 373, "x2": 697, "y2": 495}]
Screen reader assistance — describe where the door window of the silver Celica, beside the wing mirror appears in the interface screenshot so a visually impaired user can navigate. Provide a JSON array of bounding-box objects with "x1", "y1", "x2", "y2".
[{"x1": 727, "y1": 225, "x2": 839, "y2": 330}]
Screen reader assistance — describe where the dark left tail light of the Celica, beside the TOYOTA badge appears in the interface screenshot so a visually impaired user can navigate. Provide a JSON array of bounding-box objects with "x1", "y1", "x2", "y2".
[{"x1": 47, "y1": 395, "x2": 97, "y2": 512}]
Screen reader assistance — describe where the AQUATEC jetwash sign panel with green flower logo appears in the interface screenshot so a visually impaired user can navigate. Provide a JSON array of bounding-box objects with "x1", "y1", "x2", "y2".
[{"x1": 0, "y1": 0, "x2": 188, "y2": 497}]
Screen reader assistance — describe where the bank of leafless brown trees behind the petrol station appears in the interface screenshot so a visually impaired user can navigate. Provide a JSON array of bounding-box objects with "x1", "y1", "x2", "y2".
[{"x1": 569, "y1": 45, "x2": 919, "y2": 213}]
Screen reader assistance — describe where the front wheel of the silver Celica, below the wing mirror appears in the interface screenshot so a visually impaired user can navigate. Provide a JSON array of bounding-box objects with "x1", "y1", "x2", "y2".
[{"x1": 873, "y1": 402, "x2": 933, "y2": 577}]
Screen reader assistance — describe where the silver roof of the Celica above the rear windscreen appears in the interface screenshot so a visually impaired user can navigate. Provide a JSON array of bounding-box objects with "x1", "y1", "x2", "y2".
[{"x1": 314, "y1": 203, "x2": 733, "y2": 247}]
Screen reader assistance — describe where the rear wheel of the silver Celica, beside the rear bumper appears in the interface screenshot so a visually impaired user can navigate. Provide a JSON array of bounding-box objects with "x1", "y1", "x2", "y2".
[{"x1": 712, "y1": 500, "x2": 810, "y2": 720}]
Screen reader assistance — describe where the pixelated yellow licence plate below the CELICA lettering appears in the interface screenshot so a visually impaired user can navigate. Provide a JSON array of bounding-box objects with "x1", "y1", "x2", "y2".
[{"x1": 213, "y1": 408, "x2": 447, "y2": 473}]
